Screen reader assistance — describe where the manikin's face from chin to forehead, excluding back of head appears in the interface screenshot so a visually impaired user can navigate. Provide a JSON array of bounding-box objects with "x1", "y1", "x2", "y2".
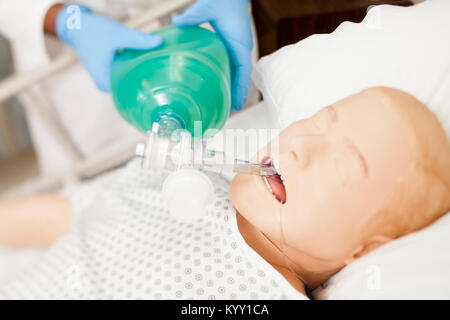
[{"x1": 230, "y1": 88, "x2": 415, "y2": 261}]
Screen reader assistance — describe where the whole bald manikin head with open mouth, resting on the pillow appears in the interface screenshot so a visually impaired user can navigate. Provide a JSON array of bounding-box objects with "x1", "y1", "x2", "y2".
[{"x1": 230, "y1": 87, "x2": 450, "y2": 284}]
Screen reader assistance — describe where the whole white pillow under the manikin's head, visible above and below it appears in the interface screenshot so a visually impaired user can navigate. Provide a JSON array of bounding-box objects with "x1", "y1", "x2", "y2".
[{"x1": 253, "y1": 0, "x2": 450, "y2": 299}]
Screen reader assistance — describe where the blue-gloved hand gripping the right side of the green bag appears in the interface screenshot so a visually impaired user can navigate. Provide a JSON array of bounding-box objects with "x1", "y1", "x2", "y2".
[{"x1": 172, "y1": 0, "x2": 253, "y2": 110}]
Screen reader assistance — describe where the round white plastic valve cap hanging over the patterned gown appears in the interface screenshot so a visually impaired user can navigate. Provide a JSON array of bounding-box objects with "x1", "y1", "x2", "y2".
[{"x1": 162, "y1": 169, "x2": 214, "y2": 223}]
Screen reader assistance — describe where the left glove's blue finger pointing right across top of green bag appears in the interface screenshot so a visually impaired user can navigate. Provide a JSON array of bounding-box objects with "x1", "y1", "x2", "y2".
[{"x1": 117, "y1": 26, "x2": 164, "y2": 50}]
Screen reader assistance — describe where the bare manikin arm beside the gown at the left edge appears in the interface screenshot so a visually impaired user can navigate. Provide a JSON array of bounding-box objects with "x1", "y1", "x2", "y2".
[{"x1": 0, "y1": 195, "x2": 73, "y2": 247}]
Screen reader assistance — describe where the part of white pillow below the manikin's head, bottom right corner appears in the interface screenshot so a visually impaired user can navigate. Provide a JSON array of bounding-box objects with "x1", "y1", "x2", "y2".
[{"x1": 313, "y1": 214, "x2": 450, "y2": 299}]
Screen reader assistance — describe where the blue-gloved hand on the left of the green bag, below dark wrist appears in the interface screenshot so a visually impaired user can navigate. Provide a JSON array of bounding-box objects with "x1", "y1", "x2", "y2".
[{"x1": 56, "y1": 5, "x2": 163, "y2": 92}]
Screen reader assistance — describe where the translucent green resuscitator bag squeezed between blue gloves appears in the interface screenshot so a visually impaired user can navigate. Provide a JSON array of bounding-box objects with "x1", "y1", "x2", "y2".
[{"x1": 111, "y1": 27, "x2": 231, "y2": 135}]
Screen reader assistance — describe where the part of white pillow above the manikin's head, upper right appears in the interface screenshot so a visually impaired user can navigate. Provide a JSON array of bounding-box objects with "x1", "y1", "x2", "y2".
[{"x1": 253, "y1": 0, "x2": 450, "y2": 137}]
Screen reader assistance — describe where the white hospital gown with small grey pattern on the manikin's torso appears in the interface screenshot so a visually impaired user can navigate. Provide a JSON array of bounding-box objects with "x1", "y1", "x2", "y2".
[{"x1": 0, "y1": 160, "x2": 306, "y2": 300}]
